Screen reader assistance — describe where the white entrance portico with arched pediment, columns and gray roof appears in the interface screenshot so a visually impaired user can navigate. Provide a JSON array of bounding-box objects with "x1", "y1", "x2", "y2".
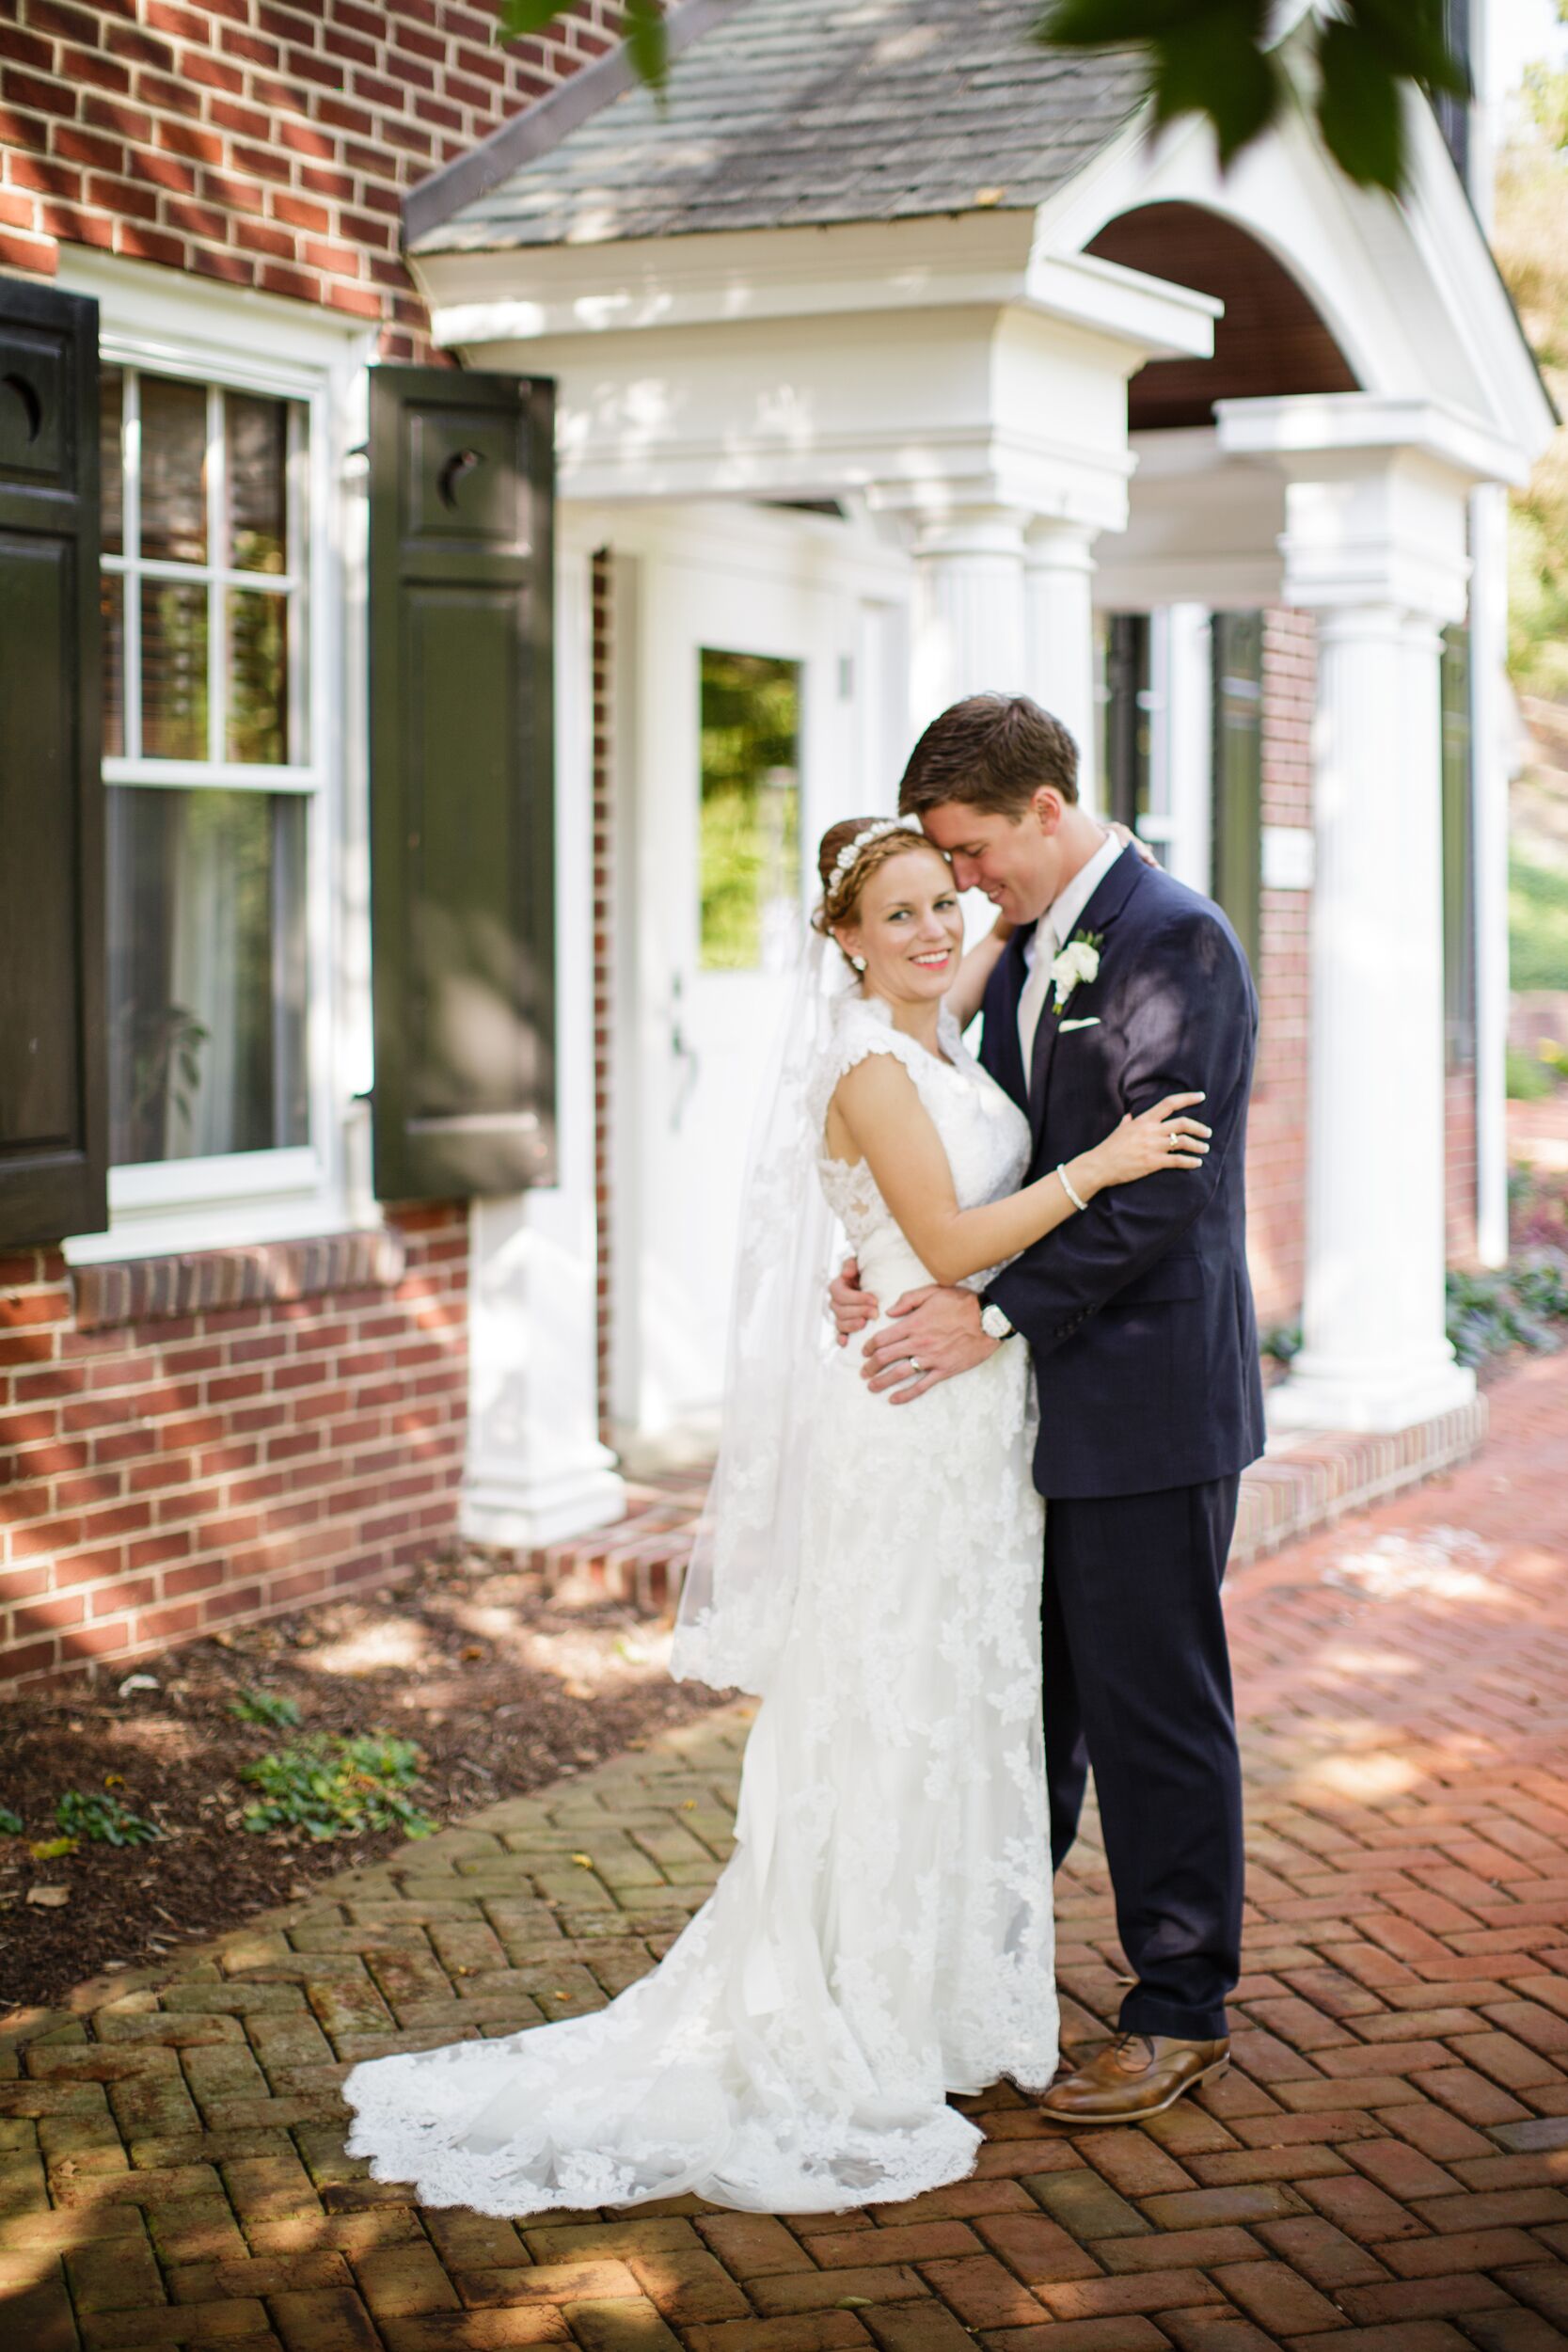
[{"x1": 409, "y1": 0, "x2": 1552, "y2": 1518}]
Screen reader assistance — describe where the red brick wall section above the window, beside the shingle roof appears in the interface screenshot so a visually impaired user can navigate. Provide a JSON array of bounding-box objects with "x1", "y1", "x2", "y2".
[{"x1": 0, "y1": 0, "x2": 618, "y2": 360}]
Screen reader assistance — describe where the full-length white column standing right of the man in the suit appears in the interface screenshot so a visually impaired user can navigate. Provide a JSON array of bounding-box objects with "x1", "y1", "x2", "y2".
[{"x1": 1270, "y1": 571, "x2": 1474, "y2": 1430}]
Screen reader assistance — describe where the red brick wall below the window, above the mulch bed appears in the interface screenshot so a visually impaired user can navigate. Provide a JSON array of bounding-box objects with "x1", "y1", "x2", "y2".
[{"x1": 0, "y1": 1204, "x2": 467, "y2": 1679}]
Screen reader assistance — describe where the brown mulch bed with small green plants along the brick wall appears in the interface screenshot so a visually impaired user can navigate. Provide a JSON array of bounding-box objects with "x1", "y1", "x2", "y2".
[{"x1": 0, "y1": 1555, "x2": 720, "y2": 2023}]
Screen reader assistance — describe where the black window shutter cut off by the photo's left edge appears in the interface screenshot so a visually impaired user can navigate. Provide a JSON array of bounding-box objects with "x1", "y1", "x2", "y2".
[{"x1": 0, "y1": 278, "x2": 108, "y2": 1247}]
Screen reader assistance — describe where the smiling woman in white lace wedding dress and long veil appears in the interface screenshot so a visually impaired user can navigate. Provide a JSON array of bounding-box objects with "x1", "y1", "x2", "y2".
[{"x1": 343, "y1": 818, "x2": 1209, "y2": 2216}]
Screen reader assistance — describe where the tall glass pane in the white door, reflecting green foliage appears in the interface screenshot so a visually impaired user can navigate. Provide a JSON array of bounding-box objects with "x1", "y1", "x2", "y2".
[{"x1": 701, "y1": 652, "x2": 800, "y2": 972}]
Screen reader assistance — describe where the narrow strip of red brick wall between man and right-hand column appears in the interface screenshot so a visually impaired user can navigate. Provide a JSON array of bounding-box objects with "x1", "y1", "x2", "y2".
[{"x1": 1246, "y1": 610, "x2": 1317, "y2": 1331}]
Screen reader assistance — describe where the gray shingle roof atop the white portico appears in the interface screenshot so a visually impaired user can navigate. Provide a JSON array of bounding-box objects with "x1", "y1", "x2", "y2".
[{"x1": 411, "y1": 0, "x2": 1143, "y2": 254}]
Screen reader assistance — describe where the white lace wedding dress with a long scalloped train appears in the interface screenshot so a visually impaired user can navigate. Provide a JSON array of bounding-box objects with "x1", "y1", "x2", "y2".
[{"x1": 343, "y1": 995, "x2": 1058, "y2": 2216}]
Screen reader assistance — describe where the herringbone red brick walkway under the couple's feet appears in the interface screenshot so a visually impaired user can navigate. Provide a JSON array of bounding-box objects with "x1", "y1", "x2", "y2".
[{"x1": 0, "y1": 1358, "x2": 1568, "y2": 2352}]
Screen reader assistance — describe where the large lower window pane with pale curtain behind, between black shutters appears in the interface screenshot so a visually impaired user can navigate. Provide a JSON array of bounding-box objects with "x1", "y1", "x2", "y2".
[{"x1": 108, "y1": 786, "x2": 308, "y2": 1167}]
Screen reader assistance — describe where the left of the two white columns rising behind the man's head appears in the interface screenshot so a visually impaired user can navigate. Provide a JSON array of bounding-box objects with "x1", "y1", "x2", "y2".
[{"x1": 910, "y1": 506, "x2": 1030, "y2": 737}]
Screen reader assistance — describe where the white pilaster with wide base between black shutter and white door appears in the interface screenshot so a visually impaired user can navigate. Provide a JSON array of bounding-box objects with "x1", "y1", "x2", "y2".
[{"x1": 461, "y1": 534, "x2": 626, "y2": 1550}]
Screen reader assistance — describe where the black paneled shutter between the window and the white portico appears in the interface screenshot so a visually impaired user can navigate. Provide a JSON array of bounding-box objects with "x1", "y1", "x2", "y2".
[{"x1": 369, "y1": 367, "x2": 555, "y2": 1200}]
